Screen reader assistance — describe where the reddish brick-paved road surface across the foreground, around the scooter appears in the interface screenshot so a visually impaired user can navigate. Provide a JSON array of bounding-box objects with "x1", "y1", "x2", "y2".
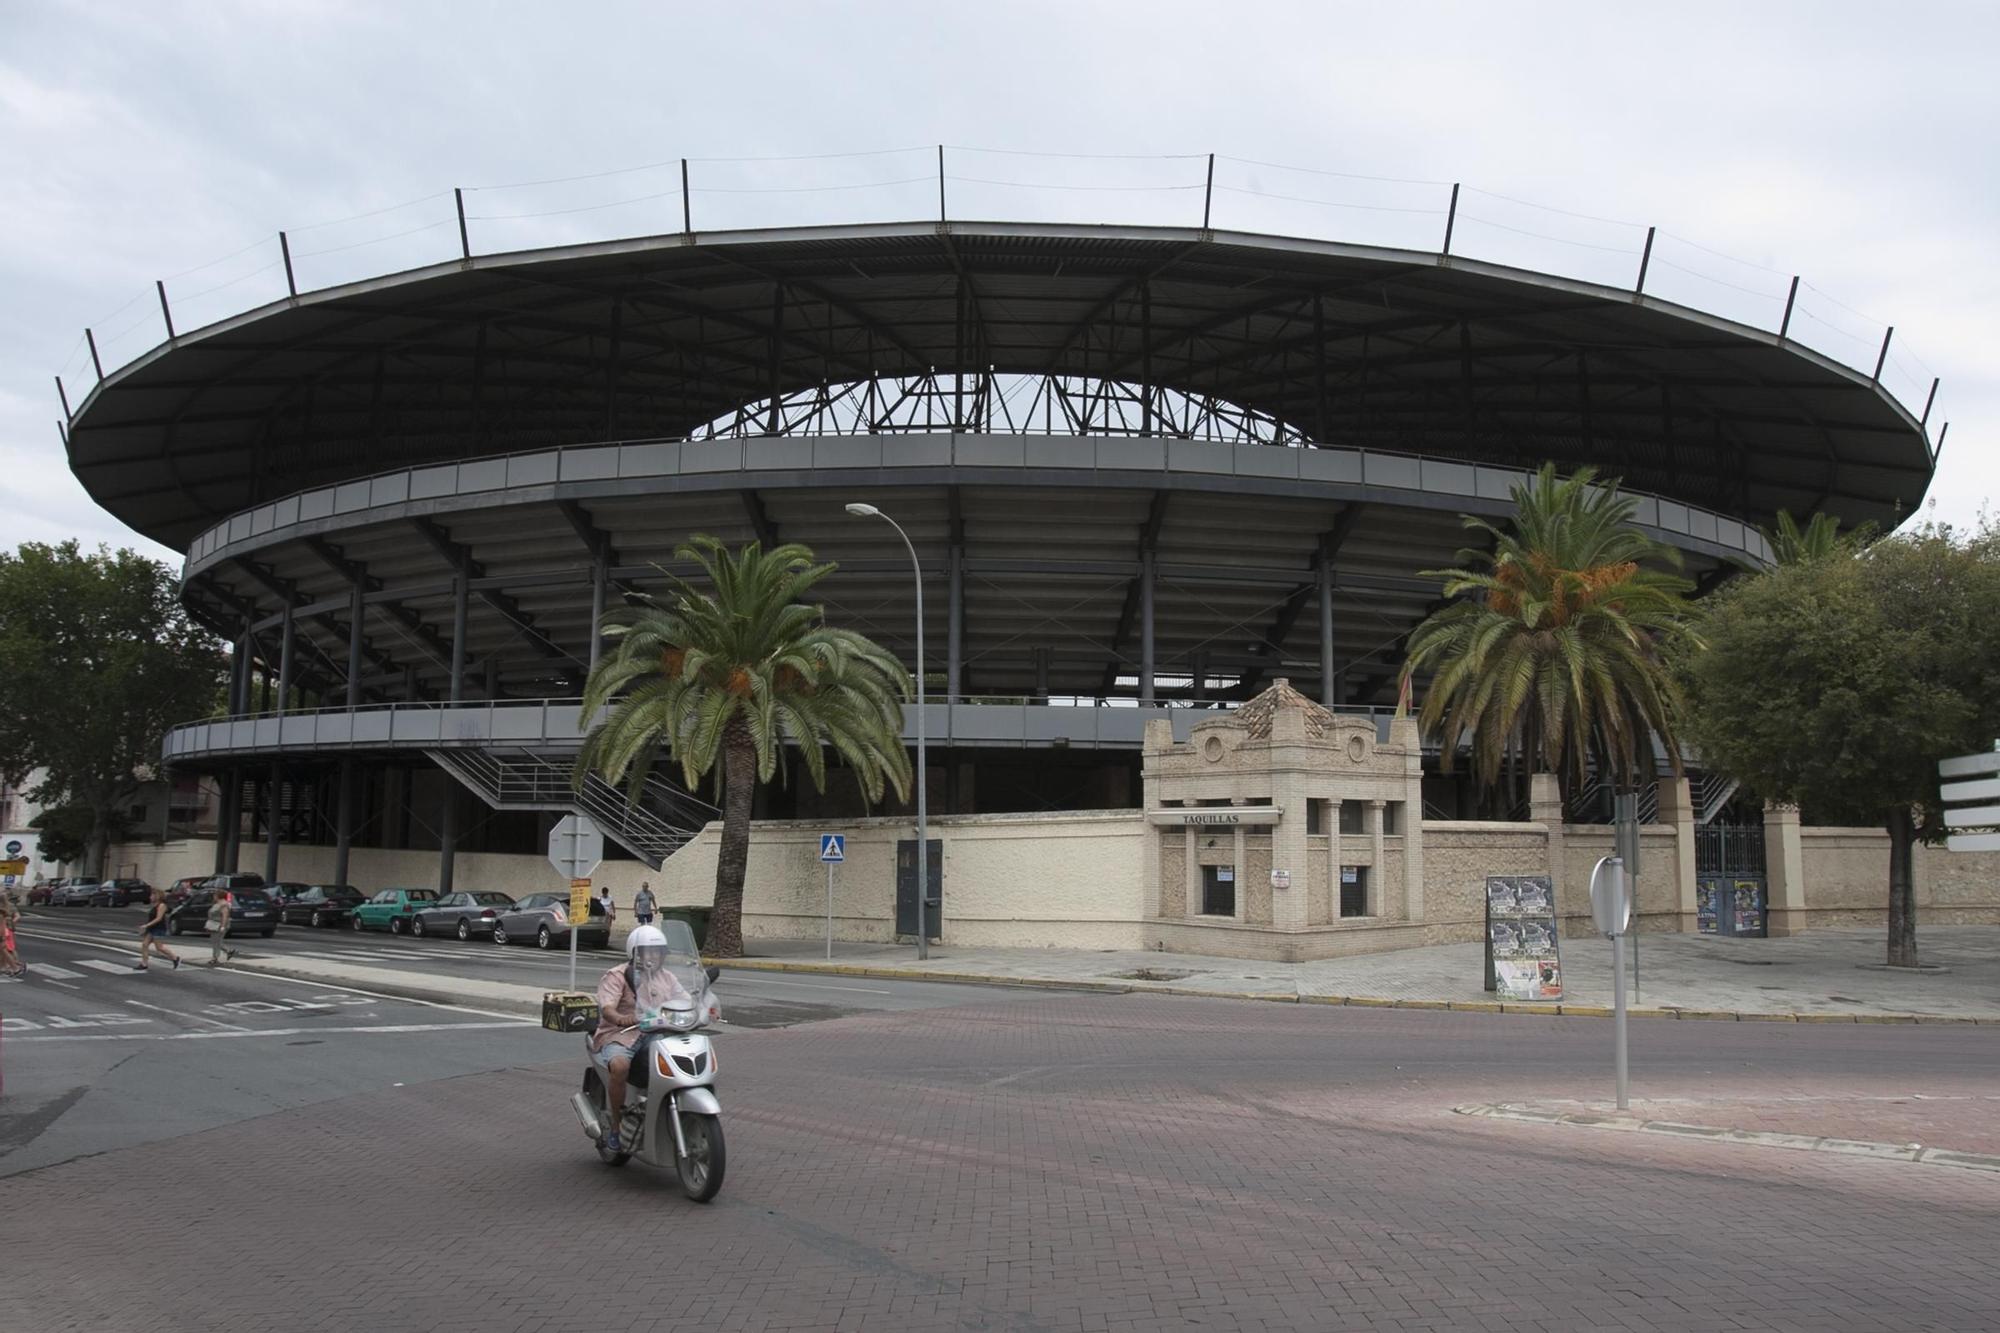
[{"x1": 0, "y1": 993, "x2": 2000, "y2": 1333}]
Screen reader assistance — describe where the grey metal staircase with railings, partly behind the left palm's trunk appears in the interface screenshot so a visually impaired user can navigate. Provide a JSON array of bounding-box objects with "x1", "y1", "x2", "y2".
[{"x1": 424, "y1": 747, "x2": 722, "y2": 871}]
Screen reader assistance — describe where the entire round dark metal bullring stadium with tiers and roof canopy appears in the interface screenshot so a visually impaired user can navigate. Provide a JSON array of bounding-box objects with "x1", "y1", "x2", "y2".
[{"x1": 66, "y1": 184, "x2": 1936, "y2": 904}]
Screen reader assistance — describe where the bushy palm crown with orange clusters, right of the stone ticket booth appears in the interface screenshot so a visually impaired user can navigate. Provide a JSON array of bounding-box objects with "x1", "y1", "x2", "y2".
[{"x1": 1402, "y1": 464, "x2": 1694, "y2": 804}]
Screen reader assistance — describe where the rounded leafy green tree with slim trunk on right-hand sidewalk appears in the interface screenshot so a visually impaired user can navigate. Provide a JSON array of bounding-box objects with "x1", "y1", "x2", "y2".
[{"x1": 1686, "y1": 524, "x2": 2000, "y2": 967}]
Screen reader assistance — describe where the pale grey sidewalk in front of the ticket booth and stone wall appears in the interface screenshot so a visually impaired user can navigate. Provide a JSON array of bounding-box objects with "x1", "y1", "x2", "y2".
[{"x1": 730, "y1": 927, "x2": 2000, "y2": 1025}]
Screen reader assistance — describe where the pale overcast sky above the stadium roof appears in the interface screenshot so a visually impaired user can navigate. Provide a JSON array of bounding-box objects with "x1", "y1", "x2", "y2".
[{"x1": 0, "y1": 0, "x2": 2000, "y2": 556}]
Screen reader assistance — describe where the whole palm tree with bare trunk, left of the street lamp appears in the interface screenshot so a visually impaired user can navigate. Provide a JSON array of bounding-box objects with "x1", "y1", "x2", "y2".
[{"x1": 576, "y1": 536, "x2": 910, "y2": 957}]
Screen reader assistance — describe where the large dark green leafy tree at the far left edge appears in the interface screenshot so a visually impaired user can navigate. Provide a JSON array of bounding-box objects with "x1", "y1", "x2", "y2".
[{"x1": 0, "y1": 540, "x2": 224, "y2": 875}]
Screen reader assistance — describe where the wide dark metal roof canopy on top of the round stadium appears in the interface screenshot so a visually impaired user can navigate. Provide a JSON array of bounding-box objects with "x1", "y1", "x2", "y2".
[{"x1": 68, "y1": 222, "x2": 1934, "y2": 546}]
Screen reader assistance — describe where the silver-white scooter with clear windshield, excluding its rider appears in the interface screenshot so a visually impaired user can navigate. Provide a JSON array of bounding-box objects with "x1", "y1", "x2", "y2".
[{"x1": 570, "y1": 921, "x2": 726, "y2": 1203}]
